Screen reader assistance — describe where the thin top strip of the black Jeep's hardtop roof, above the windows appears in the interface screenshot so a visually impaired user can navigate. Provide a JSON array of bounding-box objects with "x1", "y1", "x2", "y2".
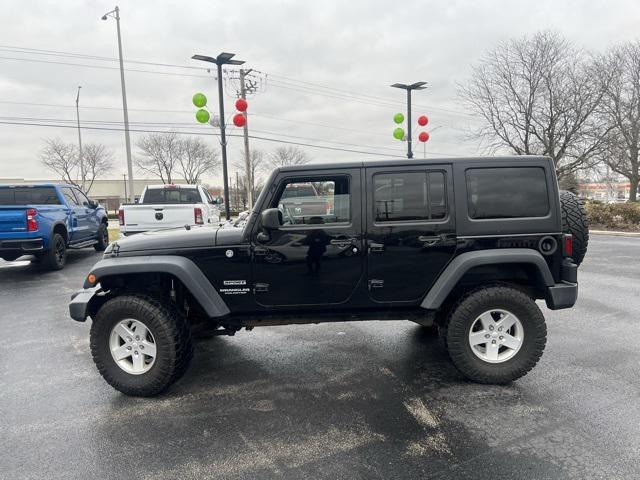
[{"x1": 276, "y1": 155, "x2": 549, "y2": 172}]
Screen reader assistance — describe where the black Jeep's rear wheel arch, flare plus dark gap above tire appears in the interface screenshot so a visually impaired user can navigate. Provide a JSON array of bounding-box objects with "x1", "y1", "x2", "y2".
[{"x1": 420, "y1": 248, "x2": 555, "y2": 310}]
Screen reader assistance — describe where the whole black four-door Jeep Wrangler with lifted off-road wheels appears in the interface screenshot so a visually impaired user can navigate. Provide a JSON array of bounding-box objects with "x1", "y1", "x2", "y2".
[{"x1": 70, "y1": 156, "x2": 588, "y2": 396}]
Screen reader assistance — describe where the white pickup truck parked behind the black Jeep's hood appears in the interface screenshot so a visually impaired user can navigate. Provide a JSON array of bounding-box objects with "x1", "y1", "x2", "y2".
[{"x1": 118, "y1": 184, "x2": 220, "y2": 235}]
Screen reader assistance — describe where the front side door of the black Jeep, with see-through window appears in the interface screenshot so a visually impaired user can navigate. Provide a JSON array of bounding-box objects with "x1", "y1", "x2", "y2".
[{"x1": 252, "y1": 168, "x2": 364, "y2": 306}]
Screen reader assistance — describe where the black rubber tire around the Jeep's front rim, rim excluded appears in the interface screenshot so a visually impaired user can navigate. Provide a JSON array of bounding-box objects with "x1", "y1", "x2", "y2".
[{"x1": 90, "y1": 294, "x2": 193, "y2": 397}]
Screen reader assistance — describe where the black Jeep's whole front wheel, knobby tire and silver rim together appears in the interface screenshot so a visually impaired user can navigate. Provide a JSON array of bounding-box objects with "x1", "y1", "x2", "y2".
[{"x1": 91, "y1": 295, "x2": 193, "y2": 397}]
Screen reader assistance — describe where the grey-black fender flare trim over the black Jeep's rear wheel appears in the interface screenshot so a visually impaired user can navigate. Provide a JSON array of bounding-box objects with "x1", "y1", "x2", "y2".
[{"x1": 420, "y1": 248, "x2": 556, "y2": 310}]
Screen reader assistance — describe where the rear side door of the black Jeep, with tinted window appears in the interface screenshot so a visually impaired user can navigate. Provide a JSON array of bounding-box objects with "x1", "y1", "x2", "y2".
[{"x1": 366, "y1": 165, "x2": 456, "y2": 302}]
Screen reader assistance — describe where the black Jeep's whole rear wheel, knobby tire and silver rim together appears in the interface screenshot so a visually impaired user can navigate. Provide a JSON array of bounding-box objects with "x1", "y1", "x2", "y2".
[{"x1": 445, "y1": 286, "x2": 547, "y2": 384}]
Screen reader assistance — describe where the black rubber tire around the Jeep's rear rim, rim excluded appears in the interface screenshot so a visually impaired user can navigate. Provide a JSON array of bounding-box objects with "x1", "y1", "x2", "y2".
[{"x1": 444, "y1": 286, "x2": 547, "y2": 385}]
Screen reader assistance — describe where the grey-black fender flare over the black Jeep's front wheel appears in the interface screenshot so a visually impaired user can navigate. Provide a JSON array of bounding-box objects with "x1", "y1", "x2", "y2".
[{"x1": 84, "y1": 255, "x2": 230, "y2": 318}]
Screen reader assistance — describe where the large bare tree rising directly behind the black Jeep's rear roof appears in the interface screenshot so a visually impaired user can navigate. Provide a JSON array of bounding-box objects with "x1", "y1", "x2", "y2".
[{"x1": 459, "y1": 32, "x2": 606, "y2": 177}]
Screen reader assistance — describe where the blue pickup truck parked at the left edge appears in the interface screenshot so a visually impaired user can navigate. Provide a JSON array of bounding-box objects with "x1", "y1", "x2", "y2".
[{"x1": 0, "y1": 183, "x2": 109, "y2": 270}]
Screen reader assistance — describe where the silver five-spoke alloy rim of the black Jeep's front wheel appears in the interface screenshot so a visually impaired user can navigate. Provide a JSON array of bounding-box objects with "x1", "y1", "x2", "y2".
[{"x1": 109, "y1": 318, "x2": 156, "y2": 375}]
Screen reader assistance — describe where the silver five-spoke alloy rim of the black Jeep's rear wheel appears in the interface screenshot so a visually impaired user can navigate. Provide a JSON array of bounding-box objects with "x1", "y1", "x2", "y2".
[{"x1": 469, "y1": 309, "x2": 524, "y2": 363}]
